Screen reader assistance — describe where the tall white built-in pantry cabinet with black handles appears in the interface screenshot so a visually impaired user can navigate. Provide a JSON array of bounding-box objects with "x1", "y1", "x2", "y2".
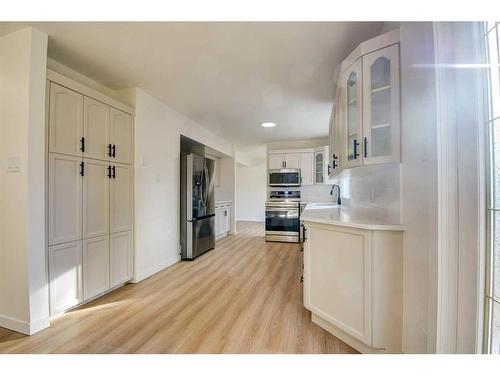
[{"x1": 47, "y1": 70, "x2": 133, "y2": 316}]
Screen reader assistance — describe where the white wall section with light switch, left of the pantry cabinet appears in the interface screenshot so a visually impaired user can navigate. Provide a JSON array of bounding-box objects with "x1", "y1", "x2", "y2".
[{"x1": 0, "y1": 28, "x2": 49, "y2": 334}]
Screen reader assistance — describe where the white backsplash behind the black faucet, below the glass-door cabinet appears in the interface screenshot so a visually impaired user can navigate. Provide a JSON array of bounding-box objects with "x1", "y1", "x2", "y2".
[{"x1": 332, "y1": 164, "x2": 401, "y2": 222}]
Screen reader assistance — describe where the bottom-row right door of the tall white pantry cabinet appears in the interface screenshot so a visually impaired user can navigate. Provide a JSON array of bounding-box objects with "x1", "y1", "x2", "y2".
[{"x1": 109, "y1": 231, "x2": 132, "y2": 288}]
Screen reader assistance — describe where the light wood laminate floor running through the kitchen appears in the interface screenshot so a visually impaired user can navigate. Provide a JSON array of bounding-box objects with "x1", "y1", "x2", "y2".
[{"x1": 0, "y1": 222, "x2": 356, "y2": 353}]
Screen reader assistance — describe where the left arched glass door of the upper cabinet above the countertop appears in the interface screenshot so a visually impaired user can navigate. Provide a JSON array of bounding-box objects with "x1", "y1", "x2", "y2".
[{"x1": 340, "y1": 59, "x2": 363, "y2": 167}]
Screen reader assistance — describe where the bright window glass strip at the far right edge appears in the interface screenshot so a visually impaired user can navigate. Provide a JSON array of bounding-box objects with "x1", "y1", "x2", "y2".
[{"x1": 485, "y1": 22, "x2": 500, "y2": 354}]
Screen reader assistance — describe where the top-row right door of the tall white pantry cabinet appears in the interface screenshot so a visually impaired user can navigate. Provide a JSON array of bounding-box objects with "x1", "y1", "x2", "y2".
[{"x1": 109, "y1": 108, "x2": 133, "y2": 164}]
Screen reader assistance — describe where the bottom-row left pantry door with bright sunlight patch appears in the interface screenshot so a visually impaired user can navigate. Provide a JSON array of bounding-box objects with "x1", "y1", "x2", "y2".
[{"x1": 49, "y1": 241, "x2": 83, "y2": 316}]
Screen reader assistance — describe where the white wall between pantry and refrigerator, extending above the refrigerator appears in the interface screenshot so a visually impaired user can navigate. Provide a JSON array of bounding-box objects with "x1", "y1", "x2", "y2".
[{"x1": 134, "y1": 89, "x2": 233, "y2": 282}]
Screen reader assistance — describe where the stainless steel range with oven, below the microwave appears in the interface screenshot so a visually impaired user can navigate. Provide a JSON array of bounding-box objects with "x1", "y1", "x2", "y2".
[{"x1": 266, "y1": 190, "x2": 300, "y2": 243}]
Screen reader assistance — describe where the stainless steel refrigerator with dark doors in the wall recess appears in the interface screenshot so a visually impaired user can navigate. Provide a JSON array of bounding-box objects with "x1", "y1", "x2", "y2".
[{"x1": 181, "y1": 153, "x2": 215, "y2": 259}]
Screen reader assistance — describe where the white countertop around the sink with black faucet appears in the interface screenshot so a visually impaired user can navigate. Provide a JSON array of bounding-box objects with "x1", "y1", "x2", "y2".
[{"x1": 301, "y1": 203, "x2": 404, "y2": 231}]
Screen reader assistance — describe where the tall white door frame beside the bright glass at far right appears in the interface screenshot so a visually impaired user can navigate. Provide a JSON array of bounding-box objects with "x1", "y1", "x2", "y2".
[{"x1": 431, "y1": 22, "x2": 486, "y2": 353}]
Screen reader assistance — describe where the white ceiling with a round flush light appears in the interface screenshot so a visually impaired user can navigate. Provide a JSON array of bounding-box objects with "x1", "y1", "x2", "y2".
[{"x1": 0, "y1": 22, "x2": 382, "y2": 144}]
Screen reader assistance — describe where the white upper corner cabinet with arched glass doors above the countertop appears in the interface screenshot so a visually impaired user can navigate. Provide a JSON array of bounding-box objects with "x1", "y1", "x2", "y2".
[{"x1": 329, "y1": 30, "x2": 401, "y2": 176}]
